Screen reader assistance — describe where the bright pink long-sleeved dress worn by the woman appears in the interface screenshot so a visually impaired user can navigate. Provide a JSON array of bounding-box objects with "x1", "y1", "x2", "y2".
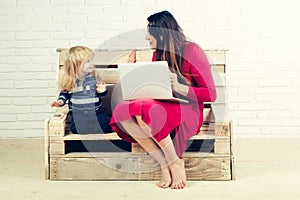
[{"x1": 110, "y1": 42, "x2": 216, "y2": 158}]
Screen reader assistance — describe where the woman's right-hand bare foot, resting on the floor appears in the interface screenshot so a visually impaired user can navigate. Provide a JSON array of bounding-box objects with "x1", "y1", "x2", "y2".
[{"x1": 169, "y1": 159, "x2": 186, "y2": 189}]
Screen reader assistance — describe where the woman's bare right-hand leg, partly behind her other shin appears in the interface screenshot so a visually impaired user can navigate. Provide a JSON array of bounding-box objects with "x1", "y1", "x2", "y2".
[{"x1": 136, "y1": 116, "x2": 186, "y2": 189}]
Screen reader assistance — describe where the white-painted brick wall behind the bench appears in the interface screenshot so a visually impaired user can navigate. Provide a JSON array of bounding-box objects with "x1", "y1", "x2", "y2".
[{"x1": 0, "y1": 0, "x2": 300, "y2": 138}]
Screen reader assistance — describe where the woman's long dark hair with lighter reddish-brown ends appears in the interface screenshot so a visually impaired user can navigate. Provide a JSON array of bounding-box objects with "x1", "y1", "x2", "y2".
[{"x1": 147, "y1": 11, "x2": 190, "y2": 84}]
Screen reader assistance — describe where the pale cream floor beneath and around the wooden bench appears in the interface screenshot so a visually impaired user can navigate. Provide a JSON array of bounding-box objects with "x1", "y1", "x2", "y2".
[{"x1": 0, "y1": 138, "x2": 300, "y2": 200}]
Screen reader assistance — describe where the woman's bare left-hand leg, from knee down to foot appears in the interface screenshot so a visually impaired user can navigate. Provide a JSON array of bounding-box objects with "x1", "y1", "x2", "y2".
[{"x1": 119, "y1": 119, "x2": 171, "y2": 188}]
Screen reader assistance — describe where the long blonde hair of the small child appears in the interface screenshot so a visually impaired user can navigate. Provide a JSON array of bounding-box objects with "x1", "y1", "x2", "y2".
[{"x1": 60, "y1": 46, "x2": 96, "y2": 91}]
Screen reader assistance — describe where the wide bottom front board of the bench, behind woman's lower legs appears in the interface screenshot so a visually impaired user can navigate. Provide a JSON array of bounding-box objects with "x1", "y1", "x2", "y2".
[{"x1": 50, "y1": 155, "x2": 230, "y2": 180}]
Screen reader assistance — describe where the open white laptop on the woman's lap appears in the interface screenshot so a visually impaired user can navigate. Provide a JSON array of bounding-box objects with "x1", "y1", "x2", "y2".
[{"x1": 118, "y1": 61, "x2": 189, "y2": 103}]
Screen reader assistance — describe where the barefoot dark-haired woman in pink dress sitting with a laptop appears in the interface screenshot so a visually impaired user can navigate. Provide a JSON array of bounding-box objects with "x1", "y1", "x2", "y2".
[{"x1": 110, "y1": 11, "x2": 216, "y2": 189}]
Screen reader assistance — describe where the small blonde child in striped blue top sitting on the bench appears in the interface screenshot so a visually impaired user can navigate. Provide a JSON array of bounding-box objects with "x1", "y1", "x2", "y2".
[{"x1": 51, "y1": 46, "x2": 113, "y2": 134}]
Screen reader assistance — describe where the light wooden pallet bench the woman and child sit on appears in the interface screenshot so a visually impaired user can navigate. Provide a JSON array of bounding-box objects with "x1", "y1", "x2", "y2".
[{"x1": 45, "y1": 49, "x2": 235, "y2": 180}]
